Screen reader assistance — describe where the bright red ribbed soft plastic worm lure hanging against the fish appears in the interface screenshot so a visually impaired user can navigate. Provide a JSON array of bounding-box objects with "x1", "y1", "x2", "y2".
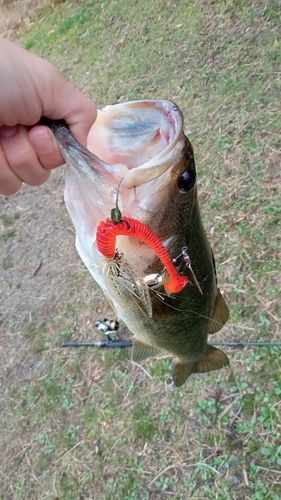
[{"x1": 96, "y1": 217, "x2": 188, "y2": 293}]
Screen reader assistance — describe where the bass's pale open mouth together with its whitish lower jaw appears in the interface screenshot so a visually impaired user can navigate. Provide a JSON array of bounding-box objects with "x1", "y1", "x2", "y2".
[{"x1": 62, "y1": 100, "x2": 186, "y2": 273}]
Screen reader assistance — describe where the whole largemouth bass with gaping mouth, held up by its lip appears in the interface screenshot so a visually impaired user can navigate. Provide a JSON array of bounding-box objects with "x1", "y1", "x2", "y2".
[{"x1": 53, "y1": 100, "x2": 229, "y2": 387}]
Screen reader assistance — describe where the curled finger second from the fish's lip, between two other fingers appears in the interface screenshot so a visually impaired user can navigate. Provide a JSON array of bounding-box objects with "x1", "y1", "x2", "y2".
[{"x1": 0, "y1": 125, "x2": 50, "y2": 186}]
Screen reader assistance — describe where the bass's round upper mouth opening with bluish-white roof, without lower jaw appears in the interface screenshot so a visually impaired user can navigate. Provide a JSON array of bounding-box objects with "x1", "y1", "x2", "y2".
[{"x1": 87, "y1": 100, "x2": 183, "y2": 189}]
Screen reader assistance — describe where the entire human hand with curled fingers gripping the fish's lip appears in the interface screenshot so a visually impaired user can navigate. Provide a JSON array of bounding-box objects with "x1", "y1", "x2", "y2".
[{"x1": 0, "y1": 39, "x2": 96, "y2": 195}]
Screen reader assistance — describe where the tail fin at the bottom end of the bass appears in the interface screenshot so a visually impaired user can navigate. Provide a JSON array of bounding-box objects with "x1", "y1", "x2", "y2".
[{"x1": 172, "y1": 345, "x2": 229, "y2": 387}]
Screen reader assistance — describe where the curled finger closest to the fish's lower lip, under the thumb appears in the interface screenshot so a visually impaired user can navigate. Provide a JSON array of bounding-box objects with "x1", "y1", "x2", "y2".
[{"x1": 27, "y1": 125, "x2": 65, "y2": 169}]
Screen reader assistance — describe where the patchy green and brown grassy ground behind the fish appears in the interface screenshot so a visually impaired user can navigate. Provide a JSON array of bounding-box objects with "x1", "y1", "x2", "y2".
[{"x1": 0, "y1": 0, "x2": 281, "y2": 500}]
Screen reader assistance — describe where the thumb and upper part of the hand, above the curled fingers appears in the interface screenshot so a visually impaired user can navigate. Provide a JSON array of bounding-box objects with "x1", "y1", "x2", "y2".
[{"x1": 0, "y1": 41, "x2": 97, "y2": 146}]
